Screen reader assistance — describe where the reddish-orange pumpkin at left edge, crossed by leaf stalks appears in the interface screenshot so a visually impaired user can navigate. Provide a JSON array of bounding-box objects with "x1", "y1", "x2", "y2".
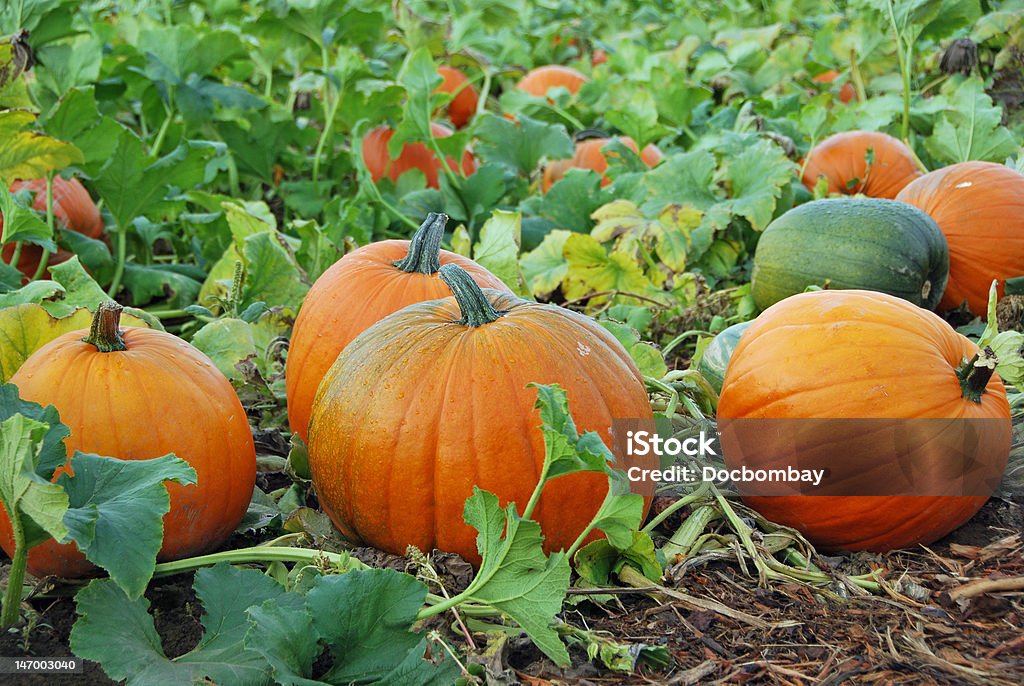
[{"x1": 0, "y1": 176, "x2": 103, "y2": 278}]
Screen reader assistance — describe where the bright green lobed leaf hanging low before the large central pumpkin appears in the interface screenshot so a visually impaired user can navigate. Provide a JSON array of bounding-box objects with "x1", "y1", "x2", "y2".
[{"x1": 464, "y1": 487, "x2": 570, "y2": 667}]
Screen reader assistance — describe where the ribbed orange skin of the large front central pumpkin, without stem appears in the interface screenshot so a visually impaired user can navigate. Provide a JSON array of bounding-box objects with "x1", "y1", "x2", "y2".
[{"x1": 309, "y1": 289, "x2": 655, "y2": 563}]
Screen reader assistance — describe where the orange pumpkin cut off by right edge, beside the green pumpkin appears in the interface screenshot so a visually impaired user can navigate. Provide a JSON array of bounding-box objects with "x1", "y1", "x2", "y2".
[{"x1": 896, "y1": 162, "x2": 1024, "y2": 316}]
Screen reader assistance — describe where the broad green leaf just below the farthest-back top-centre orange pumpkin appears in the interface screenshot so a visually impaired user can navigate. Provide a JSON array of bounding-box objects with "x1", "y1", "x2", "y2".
[{"x1": 474, "y1": 114, "x2": 573, "y2": 176}]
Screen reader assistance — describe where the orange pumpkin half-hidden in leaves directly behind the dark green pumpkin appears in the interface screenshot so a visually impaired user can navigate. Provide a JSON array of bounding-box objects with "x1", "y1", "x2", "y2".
[{"x1": 802, "y1": 131, "x2": 921, "y2": 200}]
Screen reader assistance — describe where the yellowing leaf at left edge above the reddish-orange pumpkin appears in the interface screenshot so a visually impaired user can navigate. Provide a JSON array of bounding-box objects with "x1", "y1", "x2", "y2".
[{"x1": 0, "y1": 110, "x2": 84, "y2": 185}]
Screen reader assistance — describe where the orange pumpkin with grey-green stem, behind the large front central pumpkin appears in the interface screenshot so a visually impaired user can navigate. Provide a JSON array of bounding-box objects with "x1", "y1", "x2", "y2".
[{"x1": 285, "y1": 214, "x2": 508, "y2": 440}]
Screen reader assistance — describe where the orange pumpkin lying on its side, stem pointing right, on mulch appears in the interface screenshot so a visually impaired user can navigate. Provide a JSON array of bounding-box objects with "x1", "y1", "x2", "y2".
[{"x1": 718, "y1": 291, "x2": 1012, "y2": 551}]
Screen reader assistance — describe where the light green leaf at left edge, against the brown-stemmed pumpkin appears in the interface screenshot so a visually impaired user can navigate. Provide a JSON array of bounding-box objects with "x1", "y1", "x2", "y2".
[{"x1": 0, "y1": 414, "x2": 68, "y2": 545}]
